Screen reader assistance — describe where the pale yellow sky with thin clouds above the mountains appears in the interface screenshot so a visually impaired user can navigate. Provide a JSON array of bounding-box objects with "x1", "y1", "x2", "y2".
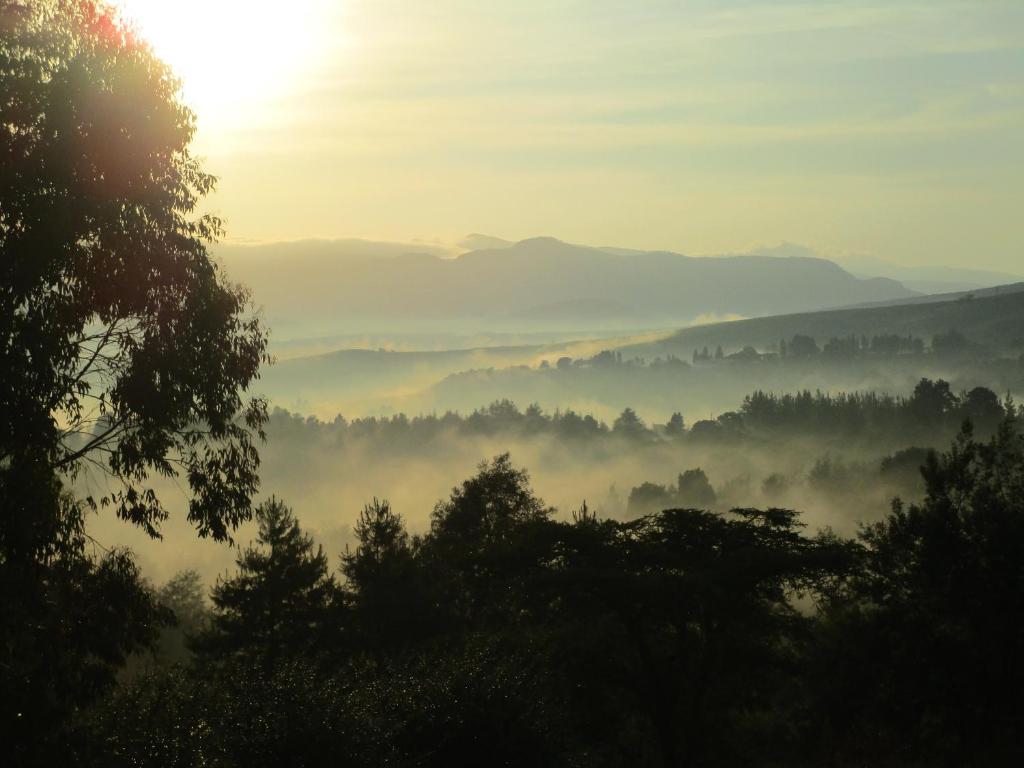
[{"x1": 121, "y1": 0, "x2": 1024, "y2": 272}]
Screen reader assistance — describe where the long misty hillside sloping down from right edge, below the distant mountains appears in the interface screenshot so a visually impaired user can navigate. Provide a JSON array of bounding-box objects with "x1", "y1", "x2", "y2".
[{"x1": 260, "y1": 287, "x2": 1024, "y2": 421}]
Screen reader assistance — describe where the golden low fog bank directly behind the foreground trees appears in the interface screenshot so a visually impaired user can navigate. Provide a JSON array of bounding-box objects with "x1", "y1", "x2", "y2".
[{"x1": 90, "y1": 415, "x2": 937, "y2": 583}]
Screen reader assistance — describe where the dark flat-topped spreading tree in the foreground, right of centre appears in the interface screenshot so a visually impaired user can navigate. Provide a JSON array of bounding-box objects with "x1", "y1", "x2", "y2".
[{"x1": 557, "y1": 510, "x2": 848, "y2": 766}]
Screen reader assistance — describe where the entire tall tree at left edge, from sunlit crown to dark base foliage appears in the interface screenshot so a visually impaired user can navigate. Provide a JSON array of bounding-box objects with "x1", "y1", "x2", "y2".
[{"x1": 0, "y1": 0, "x2": 266, "y2": 760}]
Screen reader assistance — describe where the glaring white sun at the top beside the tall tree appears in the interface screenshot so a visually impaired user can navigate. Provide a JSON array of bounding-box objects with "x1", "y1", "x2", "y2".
[{"x1": 116, "y1": 0, "x2": 336, "y2": 139}]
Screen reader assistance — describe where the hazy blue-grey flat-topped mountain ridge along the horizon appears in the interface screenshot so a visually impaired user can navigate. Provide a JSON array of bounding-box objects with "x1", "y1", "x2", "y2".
[{"x1": 219, "y1": 236, "x2": 916, "y2": 330}]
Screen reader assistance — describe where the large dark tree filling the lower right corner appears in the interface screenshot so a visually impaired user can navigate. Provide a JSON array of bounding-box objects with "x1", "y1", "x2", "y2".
[{"x1": 814, "y1": 421, "x2": 1024, "y2": 766}]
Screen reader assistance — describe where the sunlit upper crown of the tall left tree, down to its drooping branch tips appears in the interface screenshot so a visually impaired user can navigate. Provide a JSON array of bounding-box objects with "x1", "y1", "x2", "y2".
[{"x1": 0, "y1": 0, "x2": 266, "y2": 539}]
